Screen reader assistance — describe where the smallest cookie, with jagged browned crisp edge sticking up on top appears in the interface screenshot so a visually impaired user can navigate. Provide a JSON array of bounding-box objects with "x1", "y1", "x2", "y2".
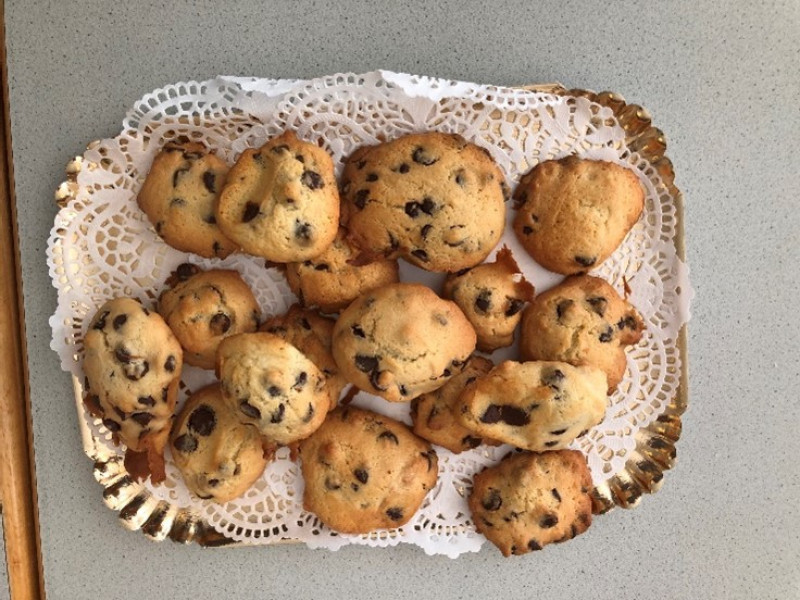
[{"x1": 443, "y1": 246, "x2": 534, "y2": 352}]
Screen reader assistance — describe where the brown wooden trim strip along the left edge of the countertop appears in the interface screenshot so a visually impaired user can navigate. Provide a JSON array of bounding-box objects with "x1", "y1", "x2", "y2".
[{"x1": 0, "y1": 3, "x2": 44, "y2": 600}]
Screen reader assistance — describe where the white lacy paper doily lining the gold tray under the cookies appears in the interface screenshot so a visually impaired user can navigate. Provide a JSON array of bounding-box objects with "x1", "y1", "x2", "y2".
[{"x1": 47, "y1": 71, "x2": 692, "y2": 557}]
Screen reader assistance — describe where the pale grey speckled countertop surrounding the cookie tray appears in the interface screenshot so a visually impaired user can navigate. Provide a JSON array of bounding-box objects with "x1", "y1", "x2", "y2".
[{"x1": 5, "y1": 0, "x2": 800, "y2": 600}]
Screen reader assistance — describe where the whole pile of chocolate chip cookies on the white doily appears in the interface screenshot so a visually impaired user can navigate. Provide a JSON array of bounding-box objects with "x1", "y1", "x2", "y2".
[{"x1": 83, "y1": 131, "x2": 644, "y2": 556}]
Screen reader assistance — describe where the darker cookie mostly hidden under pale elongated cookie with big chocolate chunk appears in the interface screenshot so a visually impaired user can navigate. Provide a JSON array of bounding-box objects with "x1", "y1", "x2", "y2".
[{"x1": 411, "y1": 356, "x2": 497, "y2": 454}]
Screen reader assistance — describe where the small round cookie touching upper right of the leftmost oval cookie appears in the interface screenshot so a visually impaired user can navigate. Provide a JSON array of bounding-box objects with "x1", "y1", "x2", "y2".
[{"x1": 158, "y1": 263, "x2": 260, "y2": 369}]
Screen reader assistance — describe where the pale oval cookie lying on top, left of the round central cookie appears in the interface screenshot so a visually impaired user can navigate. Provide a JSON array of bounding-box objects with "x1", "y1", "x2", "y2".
[{"x1": 217, "y1": 332, "x2": 330, "y2": 444}]
